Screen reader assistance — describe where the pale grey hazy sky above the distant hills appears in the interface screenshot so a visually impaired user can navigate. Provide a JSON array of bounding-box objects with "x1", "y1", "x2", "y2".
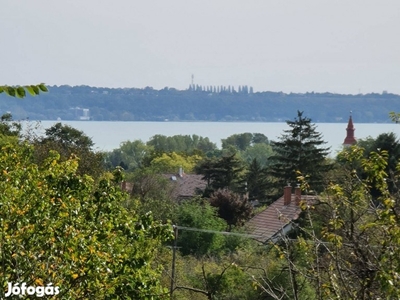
[{"x1": 0, "y1": 0, "x2": 400, "y2": 94}]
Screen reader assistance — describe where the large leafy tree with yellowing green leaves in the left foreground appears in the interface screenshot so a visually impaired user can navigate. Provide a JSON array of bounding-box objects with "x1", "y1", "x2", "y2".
[{"x1": 0, "y1": 145, "x2": 172, "y2": 299}]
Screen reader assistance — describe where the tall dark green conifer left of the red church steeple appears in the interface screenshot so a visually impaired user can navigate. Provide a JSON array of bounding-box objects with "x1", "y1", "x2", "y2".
[{"x1": 270, "y1": 111, "x2": 332, "y2": 191}]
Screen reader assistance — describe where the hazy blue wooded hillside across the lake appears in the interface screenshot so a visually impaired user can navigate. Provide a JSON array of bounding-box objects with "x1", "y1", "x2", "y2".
[{"x1": 0, "y1": 85, "x2": 400, "y2": 123}]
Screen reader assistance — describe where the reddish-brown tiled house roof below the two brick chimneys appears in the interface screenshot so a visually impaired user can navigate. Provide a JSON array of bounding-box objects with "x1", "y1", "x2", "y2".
[{"x1": 247, "y1": 194, "x2": 316, "y2": 242}]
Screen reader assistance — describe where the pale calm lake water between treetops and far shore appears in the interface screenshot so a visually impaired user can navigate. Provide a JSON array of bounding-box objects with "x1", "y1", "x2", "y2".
[{"x1": 30, "y1": 121, "x2": 400, "y2": 155}]
